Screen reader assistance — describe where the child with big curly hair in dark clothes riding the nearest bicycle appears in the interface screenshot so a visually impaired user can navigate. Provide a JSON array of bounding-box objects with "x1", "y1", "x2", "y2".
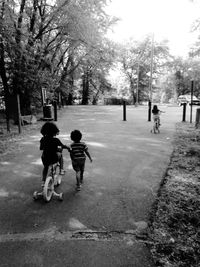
[{"x1": 40, "y1": 122, "x2": 69, "y2": 184}]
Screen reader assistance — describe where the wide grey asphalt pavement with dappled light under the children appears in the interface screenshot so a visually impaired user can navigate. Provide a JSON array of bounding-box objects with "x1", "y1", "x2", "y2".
[{"x1": 0, "y1": 106, "x2": 192, "y2": 267}]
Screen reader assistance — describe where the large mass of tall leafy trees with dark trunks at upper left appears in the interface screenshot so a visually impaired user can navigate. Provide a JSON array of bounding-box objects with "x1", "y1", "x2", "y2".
[{"x1": 0, "y1": 0, "x2": 114, "y2": 126}]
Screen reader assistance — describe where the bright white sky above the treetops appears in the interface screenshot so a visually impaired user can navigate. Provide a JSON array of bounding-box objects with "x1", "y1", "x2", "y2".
[{"x1": 107, "y1": 0, "x2": 200, "y2": 56}]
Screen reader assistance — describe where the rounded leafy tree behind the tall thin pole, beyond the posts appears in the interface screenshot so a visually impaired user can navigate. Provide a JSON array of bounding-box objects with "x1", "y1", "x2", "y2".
[{"x1": 119, "y1": 37, "x2": 169, "y2": 103}]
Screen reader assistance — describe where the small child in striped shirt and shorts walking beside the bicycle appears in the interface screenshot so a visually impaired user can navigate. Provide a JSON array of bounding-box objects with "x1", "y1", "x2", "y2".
[{"x1": 70, "y1": 130, "x2": 92, "y2": 191}]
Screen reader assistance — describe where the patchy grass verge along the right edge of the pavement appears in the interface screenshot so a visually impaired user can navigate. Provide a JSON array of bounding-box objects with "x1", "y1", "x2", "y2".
[{"x1": 149, "y1": 123, "x2": 200, "y2": 267}]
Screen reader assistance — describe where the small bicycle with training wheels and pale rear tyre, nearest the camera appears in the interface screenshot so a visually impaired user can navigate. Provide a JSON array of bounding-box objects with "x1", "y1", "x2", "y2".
[{"x1": 33, "y1": 162, "x2": 63, "y2": 202}]
